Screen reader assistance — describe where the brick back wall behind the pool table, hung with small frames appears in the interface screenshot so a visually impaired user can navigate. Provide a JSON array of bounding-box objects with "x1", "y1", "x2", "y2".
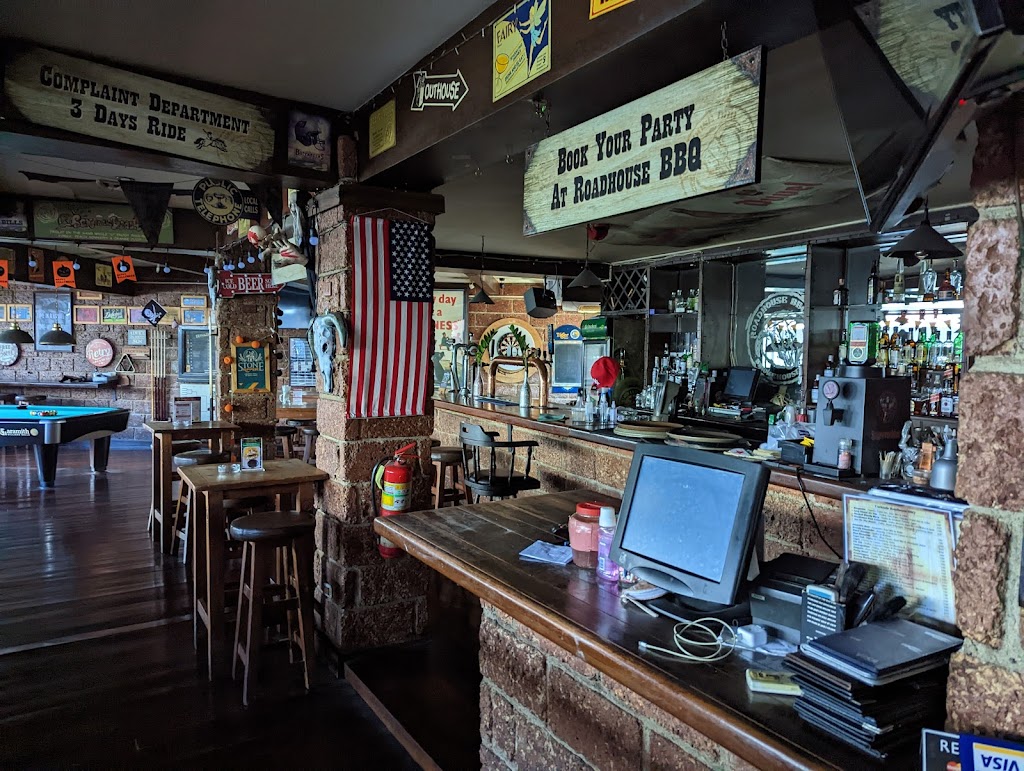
[{"x1": 0, "y1": 283, "x2": 206, "y2": 442}]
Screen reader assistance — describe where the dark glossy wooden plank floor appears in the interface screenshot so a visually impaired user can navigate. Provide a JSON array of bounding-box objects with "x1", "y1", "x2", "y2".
[{"x1": 0, "y1": 446, "x2": 416, "y2": 769}]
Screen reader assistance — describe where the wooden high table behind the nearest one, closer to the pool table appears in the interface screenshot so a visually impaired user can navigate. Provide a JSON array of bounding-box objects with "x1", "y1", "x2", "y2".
[{"x1": 145, "y1": 421, "x2": 239, "y2": 554}]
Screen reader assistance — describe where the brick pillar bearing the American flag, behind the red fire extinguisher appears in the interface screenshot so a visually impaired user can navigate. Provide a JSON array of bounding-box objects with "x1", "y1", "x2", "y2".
[{"x1": 313, "y1": 184, "x2": 441, "y2": 652}]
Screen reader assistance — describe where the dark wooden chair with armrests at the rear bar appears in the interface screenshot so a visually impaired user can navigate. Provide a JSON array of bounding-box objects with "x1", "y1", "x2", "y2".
[{"x1": 459, "y1": 423, "x2": 541, "y2": 501}]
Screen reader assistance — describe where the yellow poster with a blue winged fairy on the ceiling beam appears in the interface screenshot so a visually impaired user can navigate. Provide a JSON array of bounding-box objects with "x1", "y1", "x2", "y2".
[{"x1": 492, "y1": 0, "x2": 553, "y2": 101}]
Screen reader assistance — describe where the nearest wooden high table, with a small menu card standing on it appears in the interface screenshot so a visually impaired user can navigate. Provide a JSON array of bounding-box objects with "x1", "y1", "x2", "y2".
[{"x1": 178, "y1": 458, "x2": 328, "y2": 680}]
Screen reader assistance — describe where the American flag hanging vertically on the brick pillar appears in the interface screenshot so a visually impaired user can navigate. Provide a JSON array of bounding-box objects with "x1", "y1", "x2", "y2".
[{"x1": 348, "y1": 217, "x2": 434, "y2": 418}]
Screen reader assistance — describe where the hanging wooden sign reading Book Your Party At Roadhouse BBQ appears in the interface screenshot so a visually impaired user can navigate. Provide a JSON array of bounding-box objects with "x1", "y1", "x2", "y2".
[{"x1": 523, "y1": 48, "x2": 764, "y2": 235}]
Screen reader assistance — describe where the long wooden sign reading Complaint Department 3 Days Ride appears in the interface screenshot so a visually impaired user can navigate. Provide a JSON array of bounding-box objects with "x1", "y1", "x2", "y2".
[{"x1": 4, "y1": 48, "x2": 274, "y2": 171}]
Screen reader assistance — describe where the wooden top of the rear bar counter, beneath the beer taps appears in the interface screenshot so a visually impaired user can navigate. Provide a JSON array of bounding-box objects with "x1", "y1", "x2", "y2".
[{"x1": 434, "y1": 396, "x2": 882, "y2": 500}]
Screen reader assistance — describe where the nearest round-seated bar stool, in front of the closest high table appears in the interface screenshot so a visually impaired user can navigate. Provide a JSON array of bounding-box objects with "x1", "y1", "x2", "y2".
[{"x1": 229, "y1": 511, "x2": 313, "y2": 706}]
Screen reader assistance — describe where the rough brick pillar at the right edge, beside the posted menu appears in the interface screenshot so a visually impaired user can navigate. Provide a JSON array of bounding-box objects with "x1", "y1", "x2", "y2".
[{"x1": 946, "y1": 96, "x2": 1024, "y2": 737}]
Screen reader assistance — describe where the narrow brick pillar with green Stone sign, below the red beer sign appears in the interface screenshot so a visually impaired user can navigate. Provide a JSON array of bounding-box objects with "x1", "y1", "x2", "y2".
[{"x1": 215, "y1": 295, "x2": 280, "y2": 459}]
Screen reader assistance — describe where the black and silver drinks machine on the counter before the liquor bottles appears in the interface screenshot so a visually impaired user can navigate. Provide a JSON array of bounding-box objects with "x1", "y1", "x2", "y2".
[{"x1": 805, "y1": 365, "x2": 910, "y2": 477}]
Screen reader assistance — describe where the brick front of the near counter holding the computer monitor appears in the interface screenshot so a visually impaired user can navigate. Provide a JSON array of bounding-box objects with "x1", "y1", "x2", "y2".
[{"x1": 480, "y1": 603, "x2": 753, "y2": 771}]
